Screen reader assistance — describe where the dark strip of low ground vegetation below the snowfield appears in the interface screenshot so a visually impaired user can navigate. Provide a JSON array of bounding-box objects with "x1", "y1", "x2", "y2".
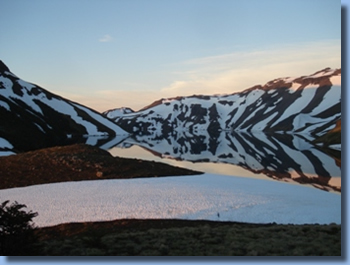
[{"x1": 33, "y1": 219, "x2": 341, "y2": 256}]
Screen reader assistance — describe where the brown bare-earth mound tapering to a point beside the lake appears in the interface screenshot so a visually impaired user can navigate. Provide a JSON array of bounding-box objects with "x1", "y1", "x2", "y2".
[{"x1": 0, "y1": 144, "x2": 202, "y2": 189}]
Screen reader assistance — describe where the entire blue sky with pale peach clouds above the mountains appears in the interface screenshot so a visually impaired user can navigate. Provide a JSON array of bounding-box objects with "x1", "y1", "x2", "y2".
[{"x1": 0, "y1": 0, "x2": 341, "y2": 112}]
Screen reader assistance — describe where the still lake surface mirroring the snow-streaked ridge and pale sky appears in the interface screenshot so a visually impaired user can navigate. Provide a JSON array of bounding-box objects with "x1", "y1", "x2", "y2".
[{"x1": 104, "y1": 131, "x2": 341, "y2": 192}]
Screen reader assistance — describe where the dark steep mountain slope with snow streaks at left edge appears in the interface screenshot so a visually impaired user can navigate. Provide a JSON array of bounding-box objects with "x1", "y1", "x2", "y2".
[{"x1": 0, "y1": 61, "x2": 127, "y2": 154}]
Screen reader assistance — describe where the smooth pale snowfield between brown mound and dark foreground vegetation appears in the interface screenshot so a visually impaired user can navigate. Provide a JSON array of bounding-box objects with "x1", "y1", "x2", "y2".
[{"x1": 0, "y1": 174, "x2": 341, "y2": 227}]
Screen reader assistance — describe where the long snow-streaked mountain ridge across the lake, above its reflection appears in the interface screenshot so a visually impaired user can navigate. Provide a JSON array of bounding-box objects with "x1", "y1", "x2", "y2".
[{"x1": 104, "y1": 68, "x2": 341, "y2": 138}]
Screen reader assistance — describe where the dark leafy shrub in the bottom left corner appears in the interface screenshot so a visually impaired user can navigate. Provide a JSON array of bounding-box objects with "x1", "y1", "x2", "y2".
[{"x1": 0, "y1": 201, "x2": 38, "y2": 256}]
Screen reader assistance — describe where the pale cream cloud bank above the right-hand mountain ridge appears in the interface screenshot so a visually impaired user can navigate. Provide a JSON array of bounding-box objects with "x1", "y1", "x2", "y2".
[{"x1": 161, "y1": 40, "x2": 341, "y2": 96}]
